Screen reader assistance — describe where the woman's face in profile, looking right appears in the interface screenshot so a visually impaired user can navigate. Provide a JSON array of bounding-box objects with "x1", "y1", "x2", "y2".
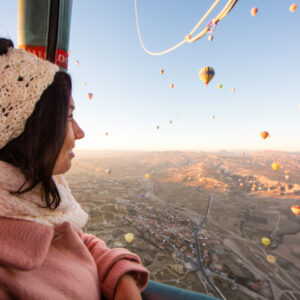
[{"x1": 53, "y1": 97, "x2": 84, "y2": 175}]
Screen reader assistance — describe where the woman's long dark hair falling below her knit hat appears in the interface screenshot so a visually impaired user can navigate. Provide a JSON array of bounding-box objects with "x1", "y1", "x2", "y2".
[{"x1": 0, "y1": 38, "x2": 72, "y2": 210}]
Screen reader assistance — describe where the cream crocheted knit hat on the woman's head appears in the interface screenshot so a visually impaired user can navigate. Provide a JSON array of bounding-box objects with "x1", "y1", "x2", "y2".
[{"x1": 0, "y1": 48, "x2": 59, "y2": 149}]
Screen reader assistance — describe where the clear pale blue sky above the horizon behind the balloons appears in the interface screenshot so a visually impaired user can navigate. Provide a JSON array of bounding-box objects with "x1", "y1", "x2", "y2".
[{"x1": 0, "y1": 0, "x2": 300, "y2": 152}]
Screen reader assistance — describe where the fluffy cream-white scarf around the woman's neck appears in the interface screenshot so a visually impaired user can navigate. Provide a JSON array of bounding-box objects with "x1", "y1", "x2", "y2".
[{"x1": 0, "y1": 161, "x2": 88, "y2": 230}]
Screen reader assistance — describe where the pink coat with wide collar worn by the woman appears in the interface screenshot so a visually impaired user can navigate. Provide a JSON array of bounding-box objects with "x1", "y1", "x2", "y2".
[{"x1": 0, "y1": 217, "x2": 149, "y2": 300}]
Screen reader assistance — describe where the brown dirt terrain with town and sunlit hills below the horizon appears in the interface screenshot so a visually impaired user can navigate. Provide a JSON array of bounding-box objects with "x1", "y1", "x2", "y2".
[{"x1": 66, "y1": 150, "x2": 300, "y2": 300}]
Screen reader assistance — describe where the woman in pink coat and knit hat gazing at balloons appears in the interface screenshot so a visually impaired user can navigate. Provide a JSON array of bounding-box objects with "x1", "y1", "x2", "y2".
[{"x1": 0, "y1": 39, "x2": 149, "y2": 300}]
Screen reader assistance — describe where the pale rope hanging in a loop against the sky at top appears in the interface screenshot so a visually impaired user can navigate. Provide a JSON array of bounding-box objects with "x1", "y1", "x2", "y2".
[{"x1": 134, "y1": 0, "x2": 238, "y2": 55}]
